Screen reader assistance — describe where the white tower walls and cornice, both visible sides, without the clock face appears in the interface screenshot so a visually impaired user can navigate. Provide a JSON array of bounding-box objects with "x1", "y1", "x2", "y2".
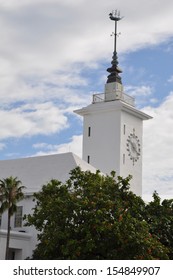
[{"x1": 75, "y1": 99, "x2": 150, "y2": 195}]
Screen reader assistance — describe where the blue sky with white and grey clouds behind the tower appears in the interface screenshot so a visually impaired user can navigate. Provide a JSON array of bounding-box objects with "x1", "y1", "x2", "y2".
[{"x1": 0, "y1": 0, "x2": 173, "y2": 201}]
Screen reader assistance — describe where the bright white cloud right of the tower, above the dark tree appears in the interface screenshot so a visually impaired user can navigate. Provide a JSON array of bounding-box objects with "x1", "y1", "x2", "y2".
[{"x1": 143, "y1": 92, "x2": 173, "y2": 198}]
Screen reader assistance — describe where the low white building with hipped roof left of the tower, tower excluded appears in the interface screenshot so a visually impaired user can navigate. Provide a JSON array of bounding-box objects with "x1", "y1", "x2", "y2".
[{"x1": 0, "y1": 153, "x2": 96, "y2": 260}]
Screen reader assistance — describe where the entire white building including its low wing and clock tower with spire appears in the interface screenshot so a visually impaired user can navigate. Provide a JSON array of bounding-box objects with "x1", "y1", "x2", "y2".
[{"x1": 0, "y1": 14, "x2": 151, "y2": 259}]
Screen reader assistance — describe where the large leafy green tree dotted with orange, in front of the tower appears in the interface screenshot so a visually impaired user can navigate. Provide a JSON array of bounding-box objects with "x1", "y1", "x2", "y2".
[{"x1": 26, "y1": 168, "x2": 168, "y2": 259}]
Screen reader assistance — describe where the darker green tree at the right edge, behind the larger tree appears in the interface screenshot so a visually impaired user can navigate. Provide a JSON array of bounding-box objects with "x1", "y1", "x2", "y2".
[{"x1": 145, "y1": 192, "x2": 173, "y2": 259}]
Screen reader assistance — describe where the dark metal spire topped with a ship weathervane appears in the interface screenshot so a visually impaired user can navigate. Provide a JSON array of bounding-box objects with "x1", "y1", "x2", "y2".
[{"x1": 107, "y1": 10, "x2": 122, "y2": 84}]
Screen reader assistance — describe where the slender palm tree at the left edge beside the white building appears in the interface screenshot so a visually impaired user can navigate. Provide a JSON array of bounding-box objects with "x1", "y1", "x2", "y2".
[{"x1": 0, "y1": 176, "x2": 25, "y2": 260}]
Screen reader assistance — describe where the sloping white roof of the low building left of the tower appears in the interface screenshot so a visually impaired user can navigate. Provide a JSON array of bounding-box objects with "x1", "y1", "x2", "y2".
[{"x1": 0, "y1": 153, "x2": 96, "y2": 193}]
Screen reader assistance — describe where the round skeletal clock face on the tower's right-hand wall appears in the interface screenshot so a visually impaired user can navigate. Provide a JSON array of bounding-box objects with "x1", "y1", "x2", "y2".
[{"x1": 127, "y1": 132, "x2": 141, "y2": 165}]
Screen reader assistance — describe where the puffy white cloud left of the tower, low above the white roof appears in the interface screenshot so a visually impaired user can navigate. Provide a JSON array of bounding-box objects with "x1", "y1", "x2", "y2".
[{"x1": 0, "y1": 102, "x2": 68, "y2": 139}]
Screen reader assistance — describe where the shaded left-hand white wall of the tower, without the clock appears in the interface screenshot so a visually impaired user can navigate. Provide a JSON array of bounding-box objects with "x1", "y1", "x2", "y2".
[{"x1": 83, "y1": 104, "x2": 120, "y2": 174}]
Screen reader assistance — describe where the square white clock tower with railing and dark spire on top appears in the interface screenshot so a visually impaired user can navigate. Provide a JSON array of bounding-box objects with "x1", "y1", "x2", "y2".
[{"x1": 75, "y1": 11, "x2": 151, "y2": 196}]
